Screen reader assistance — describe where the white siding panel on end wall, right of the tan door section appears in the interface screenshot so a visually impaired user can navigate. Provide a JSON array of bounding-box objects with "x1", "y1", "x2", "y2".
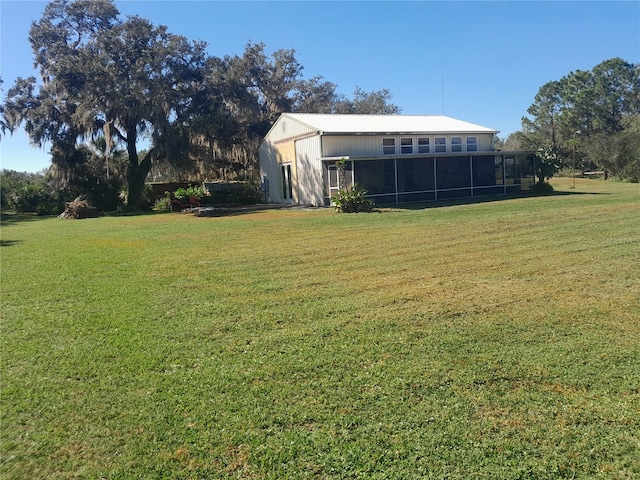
[{"x1": 296, "y1": 135, "x2": 324, "y2": 206}]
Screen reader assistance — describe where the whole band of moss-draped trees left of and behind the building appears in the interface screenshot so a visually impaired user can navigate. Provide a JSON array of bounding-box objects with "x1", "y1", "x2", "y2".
[{"x1": 0, "y1": 0, "x2": 400, "y2": 209}]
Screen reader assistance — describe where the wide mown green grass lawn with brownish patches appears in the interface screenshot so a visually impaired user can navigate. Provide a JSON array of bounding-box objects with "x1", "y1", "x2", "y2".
[{"x1": 0, "y1": 179, "x2": 640, "y2": 480}]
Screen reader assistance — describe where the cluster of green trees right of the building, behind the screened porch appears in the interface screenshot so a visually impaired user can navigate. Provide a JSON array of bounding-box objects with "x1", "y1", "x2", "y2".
[{"x1": 503, "y1": 58, "x2": 640, "y2": 182}]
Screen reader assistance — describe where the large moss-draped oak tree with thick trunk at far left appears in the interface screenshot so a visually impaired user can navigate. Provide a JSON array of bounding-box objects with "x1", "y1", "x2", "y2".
[{"x1": 4, "y1": 0, "x2": 205, "y2": 208}]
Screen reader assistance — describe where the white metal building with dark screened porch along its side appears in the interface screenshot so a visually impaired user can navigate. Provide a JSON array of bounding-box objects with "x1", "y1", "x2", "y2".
[{"x1": 259, "y1": 113, "x2": 533, "y2": 206}]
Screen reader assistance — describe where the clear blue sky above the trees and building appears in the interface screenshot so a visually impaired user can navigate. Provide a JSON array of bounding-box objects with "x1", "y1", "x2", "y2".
[{"x1": 0, "y1": 0, "x2": 640, "y2": 171}]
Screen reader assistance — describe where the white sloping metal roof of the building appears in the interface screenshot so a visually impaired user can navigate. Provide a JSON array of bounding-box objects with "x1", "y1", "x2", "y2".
[{"x1": 282, "y1": 113, "x2": 499, "y2": 135}]
